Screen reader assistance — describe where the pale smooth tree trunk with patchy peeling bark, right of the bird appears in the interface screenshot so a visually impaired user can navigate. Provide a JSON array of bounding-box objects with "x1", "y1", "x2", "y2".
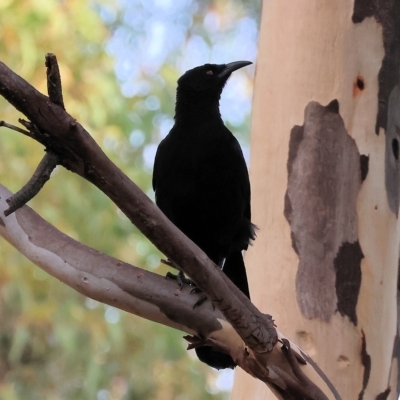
[{"x1": 232, "y1": 0, "x2": 400, "y2": 400}]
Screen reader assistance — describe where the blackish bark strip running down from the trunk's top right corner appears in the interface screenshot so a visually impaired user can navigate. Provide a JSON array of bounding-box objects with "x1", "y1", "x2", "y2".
[{"x1": 352, "y1": 0, "x2": 400, "y2": 134}]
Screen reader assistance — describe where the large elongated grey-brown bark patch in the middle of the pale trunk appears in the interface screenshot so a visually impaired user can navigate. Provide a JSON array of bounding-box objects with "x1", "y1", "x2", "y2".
[{"x1": 284, "y1": 100, "x2": 361, "y2": 321}]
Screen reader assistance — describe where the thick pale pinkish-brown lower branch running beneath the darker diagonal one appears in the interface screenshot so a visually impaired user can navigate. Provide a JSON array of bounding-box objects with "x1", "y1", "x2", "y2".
[{"x1": 0, "y1": 185, "x2": 340, "y2": 399}]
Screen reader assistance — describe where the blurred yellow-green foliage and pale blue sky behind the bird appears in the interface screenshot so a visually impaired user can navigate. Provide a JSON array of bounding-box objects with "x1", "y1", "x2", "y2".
[{"x1": 0, "y1": 0, "x2": 261, "y2": 400}]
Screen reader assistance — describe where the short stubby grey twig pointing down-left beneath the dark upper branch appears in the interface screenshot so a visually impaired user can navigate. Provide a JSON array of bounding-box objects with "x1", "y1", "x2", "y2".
[{"x1": 4, "y1": 151, "x2": 59, "y2": 216}]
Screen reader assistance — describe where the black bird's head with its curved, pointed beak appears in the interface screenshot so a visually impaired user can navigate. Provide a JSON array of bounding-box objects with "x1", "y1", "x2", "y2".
[{"x1": 178, "y1": 61, "x2": 251, "y2": 98}]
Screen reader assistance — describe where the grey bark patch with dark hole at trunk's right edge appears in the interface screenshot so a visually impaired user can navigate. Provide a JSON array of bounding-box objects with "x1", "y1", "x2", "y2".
[{"x1": 385, "y1": 86, "x2": 400, "y2": 216}]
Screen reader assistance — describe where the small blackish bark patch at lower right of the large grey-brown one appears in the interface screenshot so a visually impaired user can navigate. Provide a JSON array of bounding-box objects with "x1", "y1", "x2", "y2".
[{"x1": 334, "y1": 242, "x2": 364, "y2": 325}]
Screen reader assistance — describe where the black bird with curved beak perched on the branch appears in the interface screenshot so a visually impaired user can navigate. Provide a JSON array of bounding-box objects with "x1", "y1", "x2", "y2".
[{"x1": 153, "y1": 61, "x2": 255, "y2": 369}]
